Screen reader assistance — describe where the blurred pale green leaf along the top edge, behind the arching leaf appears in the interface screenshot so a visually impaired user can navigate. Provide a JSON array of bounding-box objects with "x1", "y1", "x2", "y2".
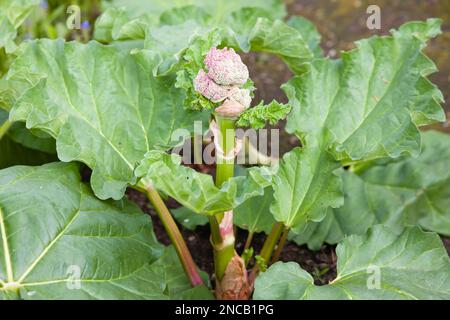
[{"x1": 94, "y1": 0, "x2": 285, "y2": 46}]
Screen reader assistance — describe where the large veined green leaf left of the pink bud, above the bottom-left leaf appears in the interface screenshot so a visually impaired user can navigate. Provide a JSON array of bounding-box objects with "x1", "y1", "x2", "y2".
[{"x1": 7, "y1": 40, "x2": 204, "y2": 199}]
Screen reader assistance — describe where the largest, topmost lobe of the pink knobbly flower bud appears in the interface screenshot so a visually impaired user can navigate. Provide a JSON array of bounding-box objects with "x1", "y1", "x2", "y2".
[{"x1": 205, "y1": 48, "x2": 249, "y2": 86}]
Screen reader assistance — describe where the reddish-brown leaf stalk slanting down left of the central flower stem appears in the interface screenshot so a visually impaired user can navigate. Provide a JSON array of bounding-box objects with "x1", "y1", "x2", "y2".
[{"x1": 139, "y1": 183, "x2": 203, "y2": 287}]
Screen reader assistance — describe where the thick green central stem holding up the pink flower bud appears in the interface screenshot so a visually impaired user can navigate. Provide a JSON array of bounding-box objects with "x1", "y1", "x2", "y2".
[{"x1": 210, "y1": 114, "x2": 236, "y2": 280}]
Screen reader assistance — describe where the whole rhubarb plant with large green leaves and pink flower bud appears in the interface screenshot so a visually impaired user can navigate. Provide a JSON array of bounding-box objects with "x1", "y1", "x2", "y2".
[{"x1": 0, "y1": 0, "x2": 450, "y2": 300}]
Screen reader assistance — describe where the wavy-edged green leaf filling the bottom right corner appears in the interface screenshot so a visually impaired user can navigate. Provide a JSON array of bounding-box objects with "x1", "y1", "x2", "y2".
[{"x1": 254, "y1": 226, "x2": 450, "y2": 300}]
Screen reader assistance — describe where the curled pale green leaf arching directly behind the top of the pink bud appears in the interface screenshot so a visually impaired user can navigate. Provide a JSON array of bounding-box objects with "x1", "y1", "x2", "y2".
[{"x1": 137, "y1": 8, "x2": 313, "y2": 82}]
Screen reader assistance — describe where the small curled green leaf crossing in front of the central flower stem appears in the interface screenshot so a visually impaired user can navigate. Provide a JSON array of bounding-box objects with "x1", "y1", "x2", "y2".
[{"x1": 136, "y1": 151, "x2": 272, "y2": 215}]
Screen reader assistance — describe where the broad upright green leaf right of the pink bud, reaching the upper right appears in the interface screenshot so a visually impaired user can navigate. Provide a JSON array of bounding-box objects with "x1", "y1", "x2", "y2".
[{"x1": 284, "y1": 19, "x2": 445, "y2": 161}]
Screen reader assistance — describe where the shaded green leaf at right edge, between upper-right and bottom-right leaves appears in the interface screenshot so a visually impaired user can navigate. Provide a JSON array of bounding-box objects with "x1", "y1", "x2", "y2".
[{"x1": 292, "y1": 131, "x2": 450, "y2": 249}]
